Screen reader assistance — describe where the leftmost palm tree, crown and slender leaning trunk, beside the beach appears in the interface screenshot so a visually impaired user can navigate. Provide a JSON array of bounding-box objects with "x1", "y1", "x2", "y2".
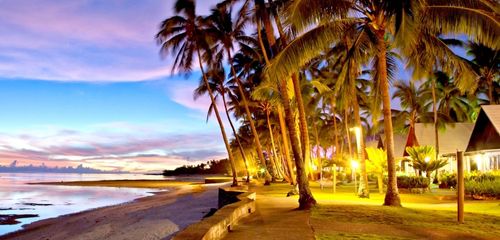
[{"x1": 156, "y1": 0, "x2": 238, "y2": 186}]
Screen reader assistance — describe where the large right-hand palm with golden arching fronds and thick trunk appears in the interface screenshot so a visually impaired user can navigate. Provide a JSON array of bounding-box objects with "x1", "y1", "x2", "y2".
[{"x1": 267, "y1": 0, "x2": 500, "y2": 206}]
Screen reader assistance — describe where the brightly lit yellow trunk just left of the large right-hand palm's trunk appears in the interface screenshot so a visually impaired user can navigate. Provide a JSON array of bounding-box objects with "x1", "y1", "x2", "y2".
[{"x1": 349, "y1": 66, "x2": 370, "y2": 198}]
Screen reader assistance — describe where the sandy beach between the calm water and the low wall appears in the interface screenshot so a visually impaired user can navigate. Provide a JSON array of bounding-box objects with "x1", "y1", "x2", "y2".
[{"x1": 0, "y1": 180, "x2": 228, "y2": 240}]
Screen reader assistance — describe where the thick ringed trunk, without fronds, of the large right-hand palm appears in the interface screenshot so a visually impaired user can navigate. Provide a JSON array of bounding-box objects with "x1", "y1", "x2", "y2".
[{"x1": 376, "y1": 36, "x2": 401, "y2": 206}]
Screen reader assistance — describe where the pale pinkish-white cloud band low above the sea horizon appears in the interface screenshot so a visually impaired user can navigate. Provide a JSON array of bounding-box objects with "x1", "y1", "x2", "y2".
[{"x1": 0, "y1": 124, "x2": 226, "y2": 172}]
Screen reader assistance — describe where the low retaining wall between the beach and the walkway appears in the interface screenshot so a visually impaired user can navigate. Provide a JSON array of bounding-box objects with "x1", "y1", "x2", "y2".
[{"x1": 172, "y1": 189, "x2": 256, "y2": 240}]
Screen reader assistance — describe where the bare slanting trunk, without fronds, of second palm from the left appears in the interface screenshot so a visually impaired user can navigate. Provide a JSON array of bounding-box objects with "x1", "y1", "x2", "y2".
[{"x1": 226, "y1": 48, "x2": 271, "y2": 185}]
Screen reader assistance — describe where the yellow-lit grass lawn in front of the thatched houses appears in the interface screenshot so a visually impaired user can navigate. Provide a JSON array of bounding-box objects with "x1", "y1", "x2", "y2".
[{"x1": 304, "y1": 182, "x2": 500, "y2": 240}]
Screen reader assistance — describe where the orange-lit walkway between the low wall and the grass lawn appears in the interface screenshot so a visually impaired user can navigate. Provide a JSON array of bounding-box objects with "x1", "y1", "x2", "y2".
[{"x1": 224, "y1": 186, "x2": 314, "y2": 240}]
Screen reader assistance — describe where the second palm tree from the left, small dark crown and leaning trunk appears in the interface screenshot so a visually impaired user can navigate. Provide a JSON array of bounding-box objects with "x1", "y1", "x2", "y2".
[{"x1": 208, "y1": 4, "x2": 269, "y2": 184}]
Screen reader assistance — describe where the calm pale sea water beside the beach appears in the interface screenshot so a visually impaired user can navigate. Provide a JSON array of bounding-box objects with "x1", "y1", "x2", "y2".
[{"x1": 0, "y1": 173, "x2": 171, "y2": 235}]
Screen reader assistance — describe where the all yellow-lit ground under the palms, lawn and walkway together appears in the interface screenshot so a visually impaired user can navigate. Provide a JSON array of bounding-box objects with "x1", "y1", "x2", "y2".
[{"x1": 228, "y1": 183, "x2": 500, "y2": 240}]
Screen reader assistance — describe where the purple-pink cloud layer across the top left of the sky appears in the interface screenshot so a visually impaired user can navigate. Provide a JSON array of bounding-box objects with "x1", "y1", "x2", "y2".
[{"x1": 0, "y1": 0, "x2": 221, "y2": 82}]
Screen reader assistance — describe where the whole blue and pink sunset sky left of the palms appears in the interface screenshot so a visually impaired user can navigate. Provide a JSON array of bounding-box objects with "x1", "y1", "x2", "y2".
[{"x1": 0, "y1": 0, "x2": 226, "y2": 172}]
